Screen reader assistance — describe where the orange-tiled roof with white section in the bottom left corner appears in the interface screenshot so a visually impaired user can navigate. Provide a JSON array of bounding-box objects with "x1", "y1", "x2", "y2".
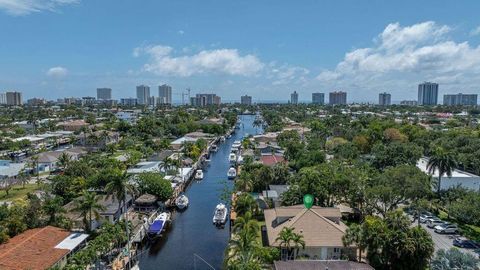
[{"x1": 0, "y1": 226, "x2": 88, "y2": 270}]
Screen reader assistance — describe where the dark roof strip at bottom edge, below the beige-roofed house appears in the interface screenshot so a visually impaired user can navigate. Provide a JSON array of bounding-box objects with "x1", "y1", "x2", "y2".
[{"x1": 273, "y1": 260, "x2": 374, "y2": 270}]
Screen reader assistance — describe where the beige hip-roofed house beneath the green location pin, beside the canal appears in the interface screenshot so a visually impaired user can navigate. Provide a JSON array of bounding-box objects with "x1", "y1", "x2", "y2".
[{"x1": 264, "y1": 205, "x2": 356, "y2": 260}]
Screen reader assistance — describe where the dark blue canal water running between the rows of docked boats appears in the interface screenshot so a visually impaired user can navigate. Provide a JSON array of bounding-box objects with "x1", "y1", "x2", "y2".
[{"x1": 139, "y1": 115, "x2": 260, "y2": 270}]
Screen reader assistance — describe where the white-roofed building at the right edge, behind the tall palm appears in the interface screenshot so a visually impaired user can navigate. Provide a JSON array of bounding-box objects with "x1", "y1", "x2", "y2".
[{"x1": 417, "y1": 157, "x2": 480, "y2": 191}]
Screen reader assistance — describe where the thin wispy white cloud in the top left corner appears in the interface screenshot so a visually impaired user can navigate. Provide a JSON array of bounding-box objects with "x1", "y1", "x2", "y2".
[{"x1": 0, "y1": 0, "x2": 80, "y2": 16}]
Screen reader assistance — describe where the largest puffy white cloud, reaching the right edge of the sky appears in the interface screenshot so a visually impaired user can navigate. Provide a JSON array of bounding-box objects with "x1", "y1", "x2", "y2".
[{"x1": 317, "y1": 21, "x2": 480, "y2": 93}]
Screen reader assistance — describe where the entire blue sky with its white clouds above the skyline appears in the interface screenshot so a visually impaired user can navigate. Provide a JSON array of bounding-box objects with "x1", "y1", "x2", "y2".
[{"x1": 0, "y1": 0, "x2": 480, "y2": 101}]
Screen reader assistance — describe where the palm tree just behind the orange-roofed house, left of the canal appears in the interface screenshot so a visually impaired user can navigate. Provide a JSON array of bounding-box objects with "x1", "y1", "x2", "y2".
[{"x1": 73, "y1": 190, "x2": 105, "y2": 232}]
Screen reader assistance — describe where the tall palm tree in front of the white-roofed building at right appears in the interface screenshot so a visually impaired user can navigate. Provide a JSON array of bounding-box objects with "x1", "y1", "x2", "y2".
[{"x1": 427, "y1": 148, "x2": 457, "y2": 194}]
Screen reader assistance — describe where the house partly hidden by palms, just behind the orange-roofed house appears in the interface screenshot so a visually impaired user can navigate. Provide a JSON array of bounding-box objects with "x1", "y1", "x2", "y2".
[{"x1": 63, "y1": 194, "x2": 133, "y2": 230}]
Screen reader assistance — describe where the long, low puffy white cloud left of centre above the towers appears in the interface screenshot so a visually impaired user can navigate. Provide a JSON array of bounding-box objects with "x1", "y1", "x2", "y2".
[{"x1": 133, "y1": 45, "x2": 264, "y2": 77}]
